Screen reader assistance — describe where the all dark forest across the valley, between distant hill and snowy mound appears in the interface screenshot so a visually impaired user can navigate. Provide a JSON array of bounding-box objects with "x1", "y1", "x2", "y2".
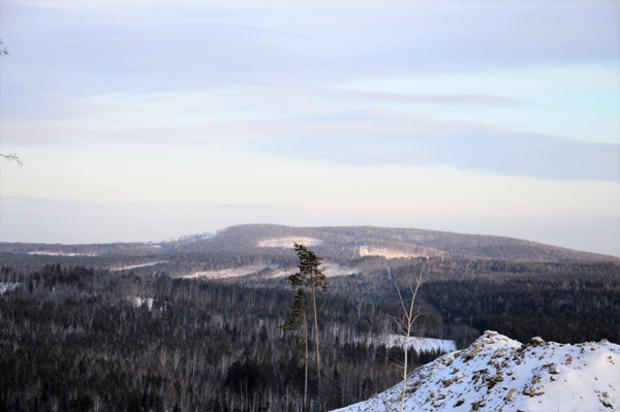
[{"x1": 0, "y1": 254, "x2": 620, "y2": 411}]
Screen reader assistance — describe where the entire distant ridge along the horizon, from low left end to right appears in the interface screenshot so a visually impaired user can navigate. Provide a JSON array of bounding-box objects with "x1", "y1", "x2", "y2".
[{"x1": 0, "y1": 224, "x2": 620, "y2": 262}]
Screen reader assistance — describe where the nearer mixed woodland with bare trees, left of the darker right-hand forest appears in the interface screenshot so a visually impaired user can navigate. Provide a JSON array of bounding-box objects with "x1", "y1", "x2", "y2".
[{"x1": 0, "y1": 265, "x2": 438, "y2": 411}]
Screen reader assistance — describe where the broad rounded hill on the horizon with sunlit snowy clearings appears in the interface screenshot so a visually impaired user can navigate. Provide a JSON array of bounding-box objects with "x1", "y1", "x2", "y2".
[{"x1": 168, "y1": 224, "x2": 618, "y2": 262}]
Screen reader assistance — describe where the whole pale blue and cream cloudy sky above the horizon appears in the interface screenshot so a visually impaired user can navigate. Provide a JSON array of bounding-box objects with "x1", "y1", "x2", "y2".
[{"x1": 0, "y1": 0, "x2": 620, "y2": 256}]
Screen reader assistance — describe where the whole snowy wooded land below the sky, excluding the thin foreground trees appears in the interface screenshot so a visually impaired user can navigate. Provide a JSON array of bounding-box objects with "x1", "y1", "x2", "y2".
[{"x1": 0, "y1": 225, "x2": 620, "y2": 411}]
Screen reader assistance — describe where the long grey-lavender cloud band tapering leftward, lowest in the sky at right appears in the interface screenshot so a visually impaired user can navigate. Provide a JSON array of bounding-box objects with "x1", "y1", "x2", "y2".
[{"x1": 3, "y1": 110, "x2": 620, "y2": 181}]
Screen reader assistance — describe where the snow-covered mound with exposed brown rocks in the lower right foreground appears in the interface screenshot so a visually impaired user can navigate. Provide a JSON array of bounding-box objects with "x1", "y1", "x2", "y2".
[{"x1": 339, "y1": 331, "x2": 620, "y2": 412}]
